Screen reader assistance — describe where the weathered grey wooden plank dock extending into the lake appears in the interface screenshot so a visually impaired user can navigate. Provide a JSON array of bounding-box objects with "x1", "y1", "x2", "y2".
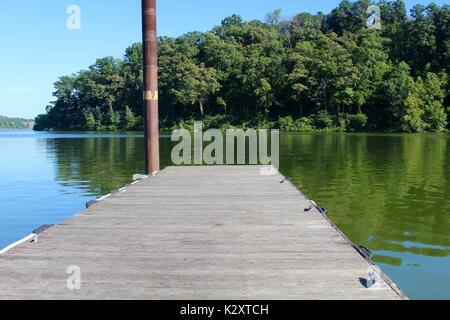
[{"x1": 0, "y1": 166, "x2": 406, "y2": 300}]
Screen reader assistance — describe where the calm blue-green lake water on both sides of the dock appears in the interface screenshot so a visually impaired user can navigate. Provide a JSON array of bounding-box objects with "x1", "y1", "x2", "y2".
[{"x1": 0, "y1": 130, "x2": 450, "y2": 299}]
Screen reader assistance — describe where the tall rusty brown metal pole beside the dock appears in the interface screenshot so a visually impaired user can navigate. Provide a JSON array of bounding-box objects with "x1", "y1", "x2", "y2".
[{"x1": 142, "y1": 0, "x2": 159, "y2": 174}]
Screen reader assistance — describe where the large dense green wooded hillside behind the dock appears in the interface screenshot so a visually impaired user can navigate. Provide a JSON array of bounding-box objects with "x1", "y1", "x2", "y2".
[{"x1": 35, "y1": 0, "x2": 450, "y2": 132}]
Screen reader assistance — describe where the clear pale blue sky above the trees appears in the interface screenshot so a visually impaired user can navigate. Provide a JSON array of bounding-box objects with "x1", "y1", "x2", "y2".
[{"x1": 0, "y1": 0, "x2": 449, "y2": 118}]
